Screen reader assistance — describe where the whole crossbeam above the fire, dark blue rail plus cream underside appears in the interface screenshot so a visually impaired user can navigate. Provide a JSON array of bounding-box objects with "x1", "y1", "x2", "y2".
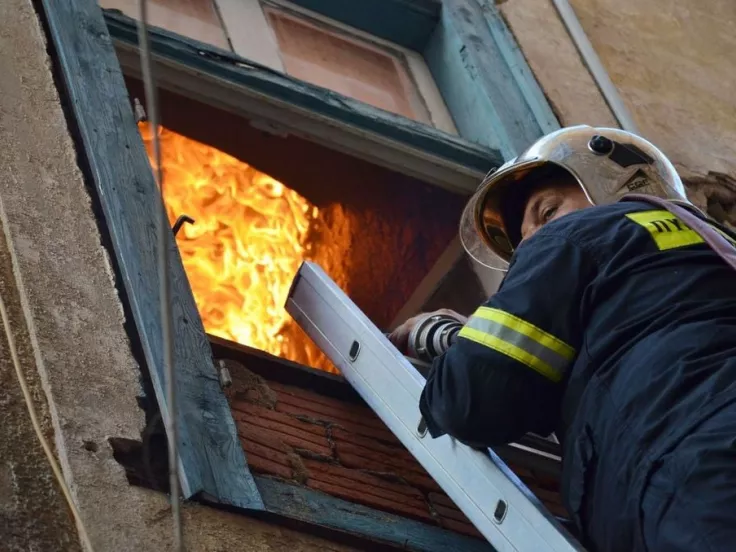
[{"x1": 105, "y1": 9, "x2": 502, "y2": 194}]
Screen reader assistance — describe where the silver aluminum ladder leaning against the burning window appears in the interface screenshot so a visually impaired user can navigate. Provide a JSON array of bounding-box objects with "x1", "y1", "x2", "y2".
[{"x1": 286, "y1": 262, "x2": 584, "y2": 552}]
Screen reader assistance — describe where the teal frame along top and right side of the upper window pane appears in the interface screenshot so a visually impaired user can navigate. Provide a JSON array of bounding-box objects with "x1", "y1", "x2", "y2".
[{"x1": 282, "y1": 0, "x2": 559, "y2": 160}]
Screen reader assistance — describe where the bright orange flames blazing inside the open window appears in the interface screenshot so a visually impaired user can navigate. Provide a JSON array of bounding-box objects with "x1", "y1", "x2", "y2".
[{"x1": 141, "y1": 124, "x2": 335, "y2": 371}]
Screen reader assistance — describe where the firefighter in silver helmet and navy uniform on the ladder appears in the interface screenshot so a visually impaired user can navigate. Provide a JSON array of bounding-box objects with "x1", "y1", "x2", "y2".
[{"x1": 390, "y1": 126, "x2": 736, "y2": 551}]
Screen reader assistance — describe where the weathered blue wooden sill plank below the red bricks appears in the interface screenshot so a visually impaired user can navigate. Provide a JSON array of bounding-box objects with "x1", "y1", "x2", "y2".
[{"x1": 255, "y1": 475, "x2": 494, "y2": 552}]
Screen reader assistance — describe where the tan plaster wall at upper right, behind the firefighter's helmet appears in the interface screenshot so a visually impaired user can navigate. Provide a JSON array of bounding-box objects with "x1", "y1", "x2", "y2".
[{"x1": 496, "y1": 0, "x2": 736, "y2": 224}]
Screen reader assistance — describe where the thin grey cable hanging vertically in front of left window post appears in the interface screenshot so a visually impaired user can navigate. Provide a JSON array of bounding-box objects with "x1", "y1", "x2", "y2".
[{"x1": 138, "y1": 0, "x2": 184, "y2": 551}]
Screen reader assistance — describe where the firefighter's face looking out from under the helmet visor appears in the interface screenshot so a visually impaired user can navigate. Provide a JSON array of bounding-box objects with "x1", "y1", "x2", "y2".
[{"x1": 521, "y1": 179, "x2": 592, "y2": 241}]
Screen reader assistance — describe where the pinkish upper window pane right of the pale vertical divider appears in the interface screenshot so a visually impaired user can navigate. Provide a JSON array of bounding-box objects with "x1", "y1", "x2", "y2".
[{"x1": 265, "y1": 8, "x2": 430, "y2": 123}]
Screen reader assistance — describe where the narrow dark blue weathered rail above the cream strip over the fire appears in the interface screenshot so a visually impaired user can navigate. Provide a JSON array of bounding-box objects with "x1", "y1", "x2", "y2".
[{"x1": 105, "y1": 12, "x2": 502, "y2": 177}]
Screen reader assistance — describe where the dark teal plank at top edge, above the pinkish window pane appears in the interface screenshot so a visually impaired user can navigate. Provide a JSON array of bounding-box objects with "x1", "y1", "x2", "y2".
[{"x1": 282, "y1": 0, "x2": 442, "y2": 52}]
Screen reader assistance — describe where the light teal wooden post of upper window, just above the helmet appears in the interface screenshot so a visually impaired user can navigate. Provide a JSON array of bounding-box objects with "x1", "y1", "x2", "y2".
[{"x1": 424, "y1": 0, "x2": 558, "y2": 159}]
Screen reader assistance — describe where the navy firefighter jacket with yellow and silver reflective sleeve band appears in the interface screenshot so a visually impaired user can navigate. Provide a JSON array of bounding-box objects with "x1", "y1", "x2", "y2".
[{"x1": 420, "y1": 202, "x2": 736, "y2": 550}]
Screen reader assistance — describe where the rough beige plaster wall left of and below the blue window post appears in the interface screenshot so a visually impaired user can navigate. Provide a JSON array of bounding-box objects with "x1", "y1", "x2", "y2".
[{"x1": 0, "y1": 0, "x2": 358, "y2": 552}]
